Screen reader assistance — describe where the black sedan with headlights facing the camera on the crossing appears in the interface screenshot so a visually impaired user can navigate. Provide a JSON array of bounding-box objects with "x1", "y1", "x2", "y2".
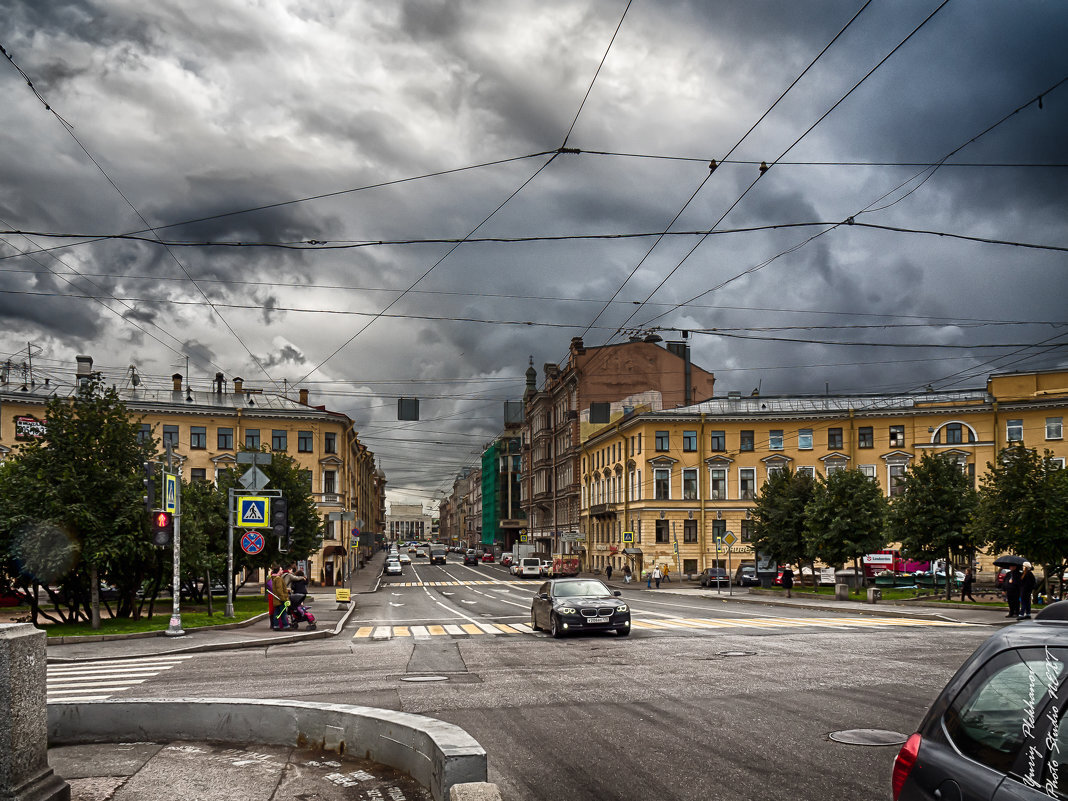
[{"x1": 531, "y1": 579, "x2": 630, "y2": 638}]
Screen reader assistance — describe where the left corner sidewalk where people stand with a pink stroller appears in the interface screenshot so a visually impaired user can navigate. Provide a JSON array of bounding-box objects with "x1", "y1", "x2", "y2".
[{"x1": 48, "y1": 551, "x2": 386, "y2": 663}]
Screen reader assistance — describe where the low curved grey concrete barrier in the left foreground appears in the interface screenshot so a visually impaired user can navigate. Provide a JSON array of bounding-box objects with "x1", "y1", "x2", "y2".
[{"x1": 48, "y1": 698, "x2": 486, "y2": 801}]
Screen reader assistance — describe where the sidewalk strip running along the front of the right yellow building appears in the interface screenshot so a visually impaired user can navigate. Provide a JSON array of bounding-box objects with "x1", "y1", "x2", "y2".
[{"x1": 593, "y1": 572, "x2": 1016, "y2": 626}]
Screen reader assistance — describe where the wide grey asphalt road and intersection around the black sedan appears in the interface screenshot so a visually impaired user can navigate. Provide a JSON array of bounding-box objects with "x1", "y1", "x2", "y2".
[{"x1": 54, "y1": 563, "x2": 990, "y2": 801}]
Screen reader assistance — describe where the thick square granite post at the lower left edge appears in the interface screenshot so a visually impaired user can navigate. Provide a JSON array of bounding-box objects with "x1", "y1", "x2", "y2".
[{"x1": 0, "y1": 623, "x2": 70, "y2": 801}]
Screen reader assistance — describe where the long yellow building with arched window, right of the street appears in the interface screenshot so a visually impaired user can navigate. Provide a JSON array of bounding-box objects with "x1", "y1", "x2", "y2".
[{"x1": 581, "y1": 371, "x2": 1068, "y2": 574}]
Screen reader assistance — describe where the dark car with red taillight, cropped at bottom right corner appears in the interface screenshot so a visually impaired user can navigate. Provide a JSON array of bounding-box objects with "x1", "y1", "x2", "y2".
[{"x1": 892, "y1": 601, "x2": 1068, "y2": 801}]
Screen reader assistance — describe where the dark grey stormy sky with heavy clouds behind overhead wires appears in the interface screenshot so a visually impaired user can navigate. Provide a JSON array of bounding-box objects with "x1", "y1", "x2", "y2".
[{"x1": 0, "y1": 0, "x2": 1068, "y2": 500}]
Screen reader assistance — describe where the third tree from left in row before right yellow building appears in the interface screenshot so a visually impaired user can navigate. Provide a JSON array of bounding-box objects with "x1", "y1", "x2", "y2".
[{"x1": 888, "y1": 453, "x2": 984, "y2": 598}]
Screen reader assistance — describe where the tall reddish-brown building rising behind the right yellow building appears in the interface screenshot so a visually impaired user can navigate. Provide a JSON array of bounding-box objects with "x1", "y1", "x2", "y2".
[{"x1": 521, "y1": 337, "x2": 716, "y2": 553}]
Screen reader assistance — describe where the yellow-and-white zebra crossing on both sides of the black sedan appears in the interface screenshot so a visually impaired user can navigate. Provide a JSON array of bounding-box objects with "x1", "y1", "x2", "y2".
[{"x1": 352, "y1": 617, "x2": 968, "y2": 640}]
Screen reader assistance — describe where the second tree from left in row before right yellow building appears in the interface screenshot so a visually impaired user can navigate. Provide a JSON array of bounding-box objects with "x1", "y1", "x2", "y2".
[{"x1": 805, "y1": 470, "x2": 886, "y2": 583}]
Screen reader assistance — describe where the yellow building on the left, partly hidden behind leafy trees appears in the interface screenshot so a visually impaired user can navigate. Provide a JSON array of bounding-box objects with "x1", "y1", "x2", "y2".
[{"x1": 0, "y1": 356, "x2": 386, "y2": 584}]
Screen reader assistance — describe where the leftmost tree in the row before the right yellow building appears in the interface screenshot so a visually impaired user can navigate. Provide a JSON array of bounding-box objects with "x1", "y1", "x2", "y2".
[{"x1": 753, "y1": 468, "x2": 819, "y2": 587}]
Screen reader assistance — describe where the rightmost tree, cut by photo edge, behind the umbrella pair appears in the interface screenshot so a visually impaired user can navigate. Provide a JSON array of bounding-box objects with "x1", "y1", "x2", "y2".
[{"x1": 972, "y1": 443, "x2": 1068, "y2": 595}]
